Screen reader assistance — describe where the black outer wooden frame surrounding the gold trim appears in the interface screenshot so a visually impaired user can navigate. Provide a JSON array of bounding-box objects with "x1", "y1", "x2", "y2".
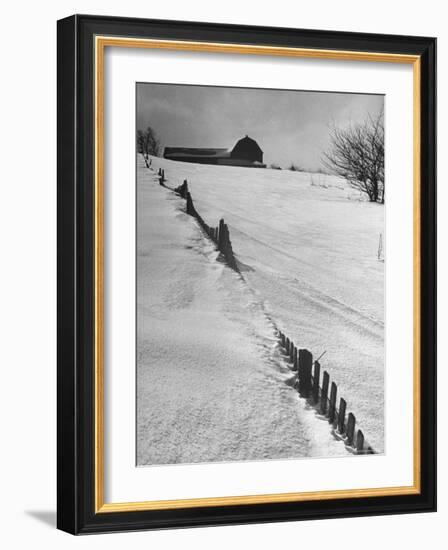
[{"x1": 57, "y1": 15, "x2": 436, "y2": 534}]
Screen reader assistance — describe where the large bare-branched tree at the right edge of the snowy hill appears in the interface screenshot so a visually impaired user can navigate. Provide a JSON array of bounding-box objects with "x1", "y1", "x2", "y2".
[{"x1": 324, "y1": 112, "x2": 385, "y2": 203}]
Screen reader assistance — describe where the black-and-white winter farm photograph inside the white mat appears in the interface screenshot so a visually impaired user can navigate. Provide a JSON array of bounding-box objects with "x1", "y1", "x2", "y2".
[{"x1": 136, "y1": 82, "x2": 387, "y2": 466}]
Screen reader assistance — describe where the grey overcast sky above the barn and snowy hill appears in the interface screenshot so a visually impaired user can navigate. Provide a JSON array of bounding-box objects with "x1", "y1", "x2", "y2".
[{"x1": 137, "y1": 83, "x2": 384, "y2": 169}]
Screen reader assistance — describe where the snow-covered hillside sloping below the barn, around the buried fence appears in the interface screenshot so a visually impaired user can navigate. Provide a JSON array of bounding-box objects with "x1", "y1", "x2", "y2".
[{"x1": 137, "y1": 158, "x2": 384, "y2": 464}]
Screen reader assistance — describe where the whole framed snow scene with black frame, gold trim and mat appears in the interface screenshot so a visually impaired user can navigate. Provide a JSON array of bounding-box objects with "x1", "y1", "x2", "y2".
[{"x1": 58, "y1": 15, "x2": 436, "y2": 534}]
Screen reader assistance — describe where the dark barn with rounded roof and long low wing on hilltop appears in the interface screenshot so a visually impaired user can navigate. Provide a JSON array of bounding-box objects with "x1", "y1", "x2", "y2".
[{"x1": 163, "y1": 136, "x2": 266, "y2": 168}]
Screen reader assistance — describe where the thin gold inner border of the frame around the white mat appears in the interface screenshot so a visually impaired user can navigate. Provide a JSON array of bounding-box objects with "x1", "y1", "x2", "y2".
[{"x1": 94, "y1": 36, "x2": 421, "y2": 513}]
